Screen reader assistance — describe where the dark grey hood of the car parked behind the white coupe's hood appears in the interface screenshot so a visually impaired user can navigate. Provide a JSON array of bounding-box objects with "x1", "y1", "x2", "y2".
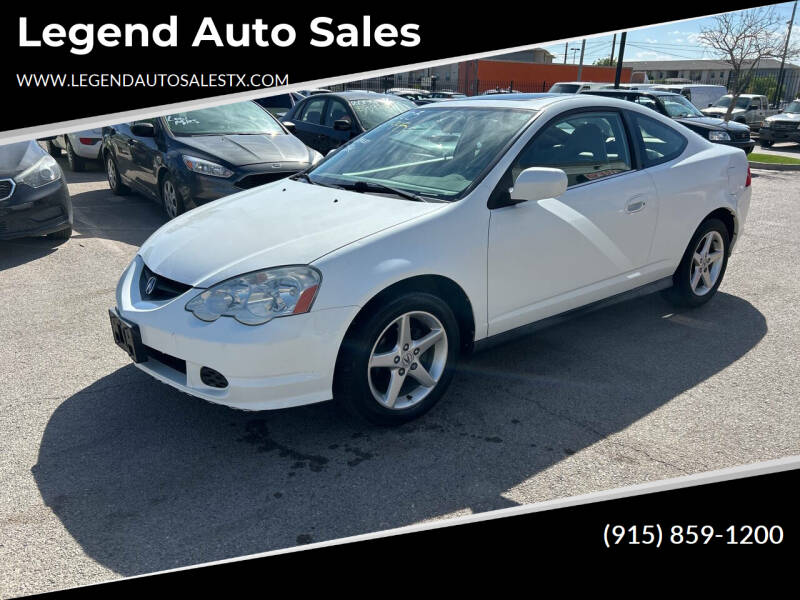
[{"x1": 176, "y1": 134, "x2": 309, "y2": 167}]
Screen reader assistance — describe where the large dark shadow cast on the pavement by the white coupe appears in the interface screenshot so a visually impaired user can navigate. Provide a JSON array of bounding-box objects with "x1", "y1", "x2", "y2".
[{"x1": 33, "y1": 293, "x2": 767, "y2": 575}]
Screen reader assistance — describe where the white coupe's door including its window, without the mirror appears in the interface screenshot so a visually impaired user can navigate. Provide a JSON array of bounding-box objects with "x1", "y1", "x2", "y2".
[{"x1": 487, "y1": 109, "x2": 658, "y2": 335}]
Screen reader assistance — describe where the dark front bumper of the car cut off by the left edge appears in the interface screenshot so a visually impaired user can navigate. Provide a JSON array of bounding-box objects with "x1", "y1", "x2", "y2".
[{"x1": 0, "y1": 177, "x2": 72, "y2": 240}]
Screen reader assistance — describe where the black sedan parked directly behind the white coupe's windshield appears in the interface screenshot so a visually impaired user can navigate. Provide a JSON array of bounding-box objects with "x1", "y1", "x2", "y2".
[{"x1": 283, "y1": 91, "x2": 416, "y2": 155}]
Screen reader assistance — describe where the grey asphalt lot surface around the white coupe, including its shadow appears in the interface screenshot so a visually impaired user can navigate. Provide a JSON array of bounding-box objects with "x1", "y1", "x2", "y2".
[{"x1": 0, "y1": 161, "x2": 800, "y2": 597}]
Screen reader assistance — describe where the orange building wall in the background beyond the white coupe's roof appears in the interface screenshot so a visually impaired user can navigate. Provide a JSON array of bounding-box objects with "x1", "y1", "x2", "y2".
[{"x1": 462, "y1": 60, "x2": 632, "y2": 93}]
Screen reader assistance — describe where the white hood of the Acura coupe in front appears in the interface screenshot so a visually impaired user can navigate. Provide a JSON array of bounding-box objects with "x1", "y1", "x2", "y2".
[{"x1": 139, "y1": 179, "x2": 446, "y2": 288}]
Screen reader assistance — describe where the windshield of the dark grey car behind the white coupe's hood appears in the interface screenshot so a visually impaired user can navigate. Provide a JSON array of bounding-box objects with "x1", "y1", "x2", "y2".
[{"x1": 164, "y1": 102, "x2": 283, "y2": 136}]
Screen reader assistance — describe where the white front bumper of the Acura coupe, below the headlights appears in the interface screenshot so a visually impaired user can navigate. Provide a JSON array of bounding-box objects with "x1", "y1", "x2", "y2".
[{"x1": 114, "y1": 255, "x2": 358, "y2": 410}]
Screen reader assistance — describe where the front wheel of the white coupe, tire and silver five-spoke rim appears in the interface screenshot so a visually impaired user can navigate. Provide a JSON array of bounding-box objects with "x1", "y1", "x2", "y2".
[{"x1": 334, "y1": 293, "x2": 460, "y2": 425}]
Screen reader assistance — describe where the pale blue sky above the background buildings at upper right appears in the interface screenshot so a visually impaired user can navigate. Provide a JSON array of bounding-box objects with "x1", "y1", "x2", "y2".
[{"x1": 542, "y1": 2, "x2": 800, "y2": 65}]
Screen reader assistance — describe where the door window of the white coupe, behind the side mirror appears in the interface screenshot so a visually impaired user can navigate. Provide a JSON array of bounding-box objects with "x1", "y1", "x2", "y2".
[{"x1": 489, "y1": 112, "x2": 633, "y2": 207}]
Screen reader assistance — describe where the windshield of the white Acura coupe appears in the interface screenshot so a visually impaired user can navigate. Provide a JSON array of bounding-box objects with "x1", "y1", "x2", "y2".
[{"x1": 309, "y1": 107, "x2": 535, "y2": 200}]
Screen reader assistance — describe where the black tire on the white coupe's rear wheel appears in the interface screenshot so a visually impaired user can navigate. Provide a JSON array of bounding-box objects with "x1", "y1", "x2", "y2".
[{"x1": 666, "y1": 218, "x2": 730, "y2": 307}]
